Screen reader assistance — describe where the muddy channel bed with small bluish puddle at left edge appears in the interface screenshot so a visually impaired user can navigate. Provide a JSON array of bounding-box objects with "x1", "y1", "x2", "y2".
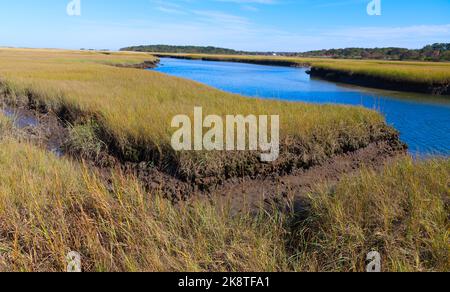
[{"x1": 0, "y1": 102, "x2": 196, "y2": 202}]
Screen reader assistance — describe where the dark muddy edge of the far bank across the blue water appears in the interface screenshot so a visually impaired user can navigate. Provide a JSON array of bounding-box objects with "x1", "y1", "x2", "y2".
[{"x1": 152, "y1": 53, "x2": 450, "y2": 98}]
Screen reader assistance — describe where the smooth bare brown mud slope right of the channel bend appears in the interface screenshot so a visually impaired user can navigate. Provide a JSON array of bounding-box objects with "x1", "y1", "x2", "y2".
[{"x1": 212, "y1": 141, "x2": 406, "y2": 211}]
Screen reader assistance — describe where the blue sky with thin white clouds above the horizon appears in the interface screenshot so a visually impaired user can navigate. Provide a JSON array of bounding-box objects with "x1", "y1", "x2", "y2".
[{"x1": 0, "y1": 0, "x2": 450, "y2": 51}]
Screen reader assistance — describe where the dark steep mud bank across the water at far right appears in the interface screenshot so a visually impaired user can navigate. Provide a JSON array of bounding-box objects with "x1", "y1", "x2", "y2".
[{"x1": 309, "y1": 67, "x2": 450, "y2": 95}]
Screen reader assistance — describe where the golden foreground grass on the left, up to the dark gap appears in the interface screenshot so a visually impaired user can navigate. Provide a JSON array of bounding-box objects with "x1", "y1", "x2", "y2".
[{"x1": 0, "y1": 138, "x2": 289, "y2": 271}]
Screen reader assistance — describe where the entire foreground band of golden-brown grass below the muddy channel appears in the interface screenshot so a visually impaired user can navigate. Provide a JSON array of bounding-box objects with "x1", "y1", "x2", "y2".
[{"x1": 0, "y1": 130, "x2": 444, "y2": 272}]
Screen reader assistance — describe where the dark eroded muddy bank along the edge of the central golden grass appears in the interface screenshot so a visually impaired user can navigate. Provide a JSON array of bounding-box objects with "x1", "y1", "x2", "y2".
[{"x1": 0, "y1": 79, "x2": 406, "y2": 208}]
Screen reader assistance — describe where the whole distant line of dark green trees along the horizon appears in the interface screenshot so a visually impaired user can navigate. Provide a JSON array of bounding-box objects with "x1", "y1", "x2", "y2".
[{"x1": 121, "y1": 43, "x2": 450, "y2": 62}]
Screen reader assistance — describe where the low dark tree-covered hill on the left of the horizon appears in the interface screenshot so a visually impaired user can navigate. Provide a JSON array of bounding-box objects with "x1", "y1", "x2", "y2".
[{"x1": 120, "y1": 45, "x2": 242, "y2": 55}]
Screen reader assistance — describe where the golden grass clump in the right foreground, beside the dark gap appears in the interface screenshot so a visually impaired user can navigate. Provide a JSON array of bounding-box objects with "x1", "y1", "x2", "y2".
[{"x1": 291, "y1": 158, "x2": 450, "y2": 272}]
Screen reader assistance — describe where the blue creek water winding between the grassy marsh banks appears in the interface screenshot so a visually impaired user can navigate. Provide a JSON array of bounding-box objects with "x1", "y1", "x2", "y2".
[{"x1": 152, "y1": 58, "x2": 450, "y2": 156}]
